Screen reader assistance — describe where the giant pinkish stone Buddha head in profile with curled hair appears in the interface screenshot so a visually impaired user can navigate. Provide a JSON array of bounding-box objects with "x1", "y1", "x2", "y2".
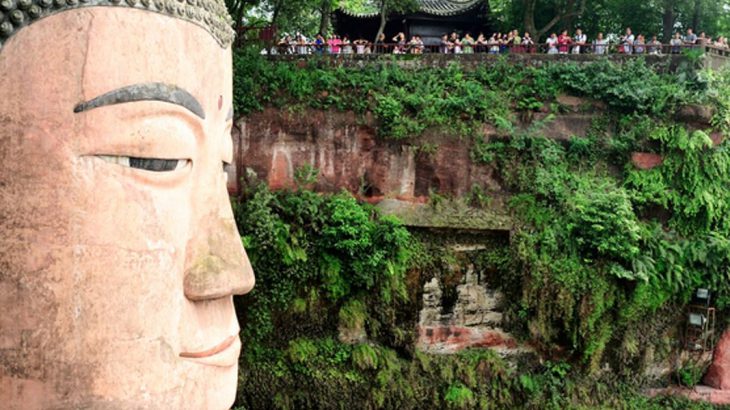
[{"x1": 0, "y1": 0, "x2": 254, "y2": 409}]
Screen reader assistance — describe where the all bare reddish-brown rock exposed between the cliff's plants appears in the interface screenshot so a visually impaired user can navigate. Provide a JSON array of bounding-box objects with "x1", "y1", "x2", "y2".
[{"x1": 229, "y1": 96, "x2": 726, "y2": 400}]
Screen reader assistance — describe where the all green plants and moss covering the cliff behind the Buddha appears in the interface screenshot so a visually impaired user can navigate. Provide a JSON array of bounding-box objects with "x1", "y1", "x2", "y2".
[{"x1": 234, "y1": 55, "x2": 730, "y2": 409}]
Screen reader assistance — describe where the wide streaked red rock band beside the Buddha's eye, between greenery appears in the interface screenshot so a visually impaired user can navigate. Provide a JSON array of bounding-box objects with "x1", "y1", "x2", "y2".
[{"x1": 234, "y1": 109, "x2": 500, "y2": 202}]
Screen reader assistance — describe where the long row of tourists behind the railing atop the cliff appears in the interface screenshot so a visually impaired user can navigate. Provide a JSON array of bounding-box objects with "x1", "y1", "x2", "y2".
[{"x1": 271, "y1": 28, "x2": 730, "y2": 55}]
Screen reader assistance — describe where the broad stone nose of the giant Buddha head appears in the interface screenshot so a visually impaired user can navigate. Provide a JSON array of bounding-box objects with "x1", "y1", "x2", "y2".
[{"x1": 184, "y1": 191, "x2": 255, "y2": 301}]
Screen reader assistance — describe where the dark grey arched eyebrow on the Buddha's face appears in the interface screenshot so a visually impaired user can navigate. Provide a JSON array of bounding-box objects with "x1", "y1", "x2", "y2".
[{"x1": 74, "y1": 83, "x2": 205, "y2": 119}]
